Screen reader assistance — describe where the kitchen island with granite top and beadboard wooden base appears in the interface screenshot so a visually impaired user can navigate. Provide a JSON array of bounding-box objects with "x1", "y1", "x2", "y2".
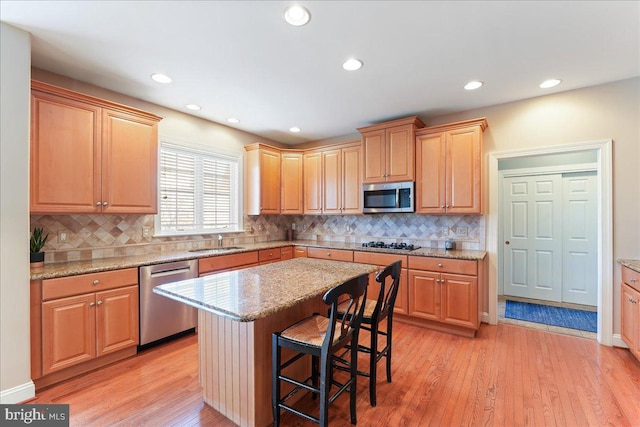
[{"x1": 154, "y1": 258, "x2": 378, "y2": 427}]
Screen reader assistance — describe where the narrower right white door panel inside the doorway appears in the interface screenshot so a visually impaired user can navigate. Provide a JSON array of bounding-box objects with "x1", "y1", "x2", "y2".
[{"x1": 562, "y1": 172, "x2": 598, "y2": 305}]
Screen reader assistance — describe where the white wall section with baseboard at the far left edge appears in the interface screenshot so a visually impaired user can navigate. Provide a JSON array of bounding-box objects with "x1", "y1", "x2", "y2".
[{"x1": 0, "y1": 23, "x2": 35, "y2": 403}]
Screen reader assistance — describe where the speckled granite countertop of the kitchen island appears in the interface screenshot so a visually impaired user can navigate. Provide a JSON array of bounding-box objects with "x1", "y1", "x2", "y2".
[{"x1": 153, "y1": 258, "x2": 378, "y2": 322}]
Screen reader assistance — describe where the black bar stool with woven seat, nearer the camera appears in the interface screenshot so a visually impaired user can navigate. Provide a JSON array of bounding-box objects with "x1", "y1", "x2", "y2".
[{"x1": 272, "y1": 274, "x2": 368, "y2": 427}]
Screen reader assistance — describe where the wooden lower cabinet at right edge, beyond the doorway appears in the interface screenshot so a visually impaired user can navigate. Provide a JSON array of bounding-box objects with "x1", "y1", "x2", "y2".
[{"x1": 620, "y1": 266, "x2": 640, "y2": 360}]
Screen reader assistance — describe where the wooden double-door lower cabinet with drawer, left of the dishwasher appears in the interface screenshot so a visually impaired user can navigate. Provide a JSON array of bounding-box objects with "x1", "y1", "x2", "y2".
[{"x1": 31, "y1": 268, "x2": 139, "y2": 388}]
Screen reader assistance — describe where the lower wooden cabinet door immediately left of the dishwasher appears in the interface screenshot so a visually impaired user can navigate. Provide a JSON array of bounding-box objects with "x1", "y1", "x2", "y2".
[{"x1": 96, "y1": 286, "x2": 139, "y2": 357}]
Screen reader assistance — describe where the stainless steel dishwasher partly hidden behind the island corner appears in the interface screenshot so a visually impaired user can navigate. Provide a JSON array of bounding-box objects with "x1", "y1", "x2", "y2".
[{"x1": 139, "y1": 260, "x2": 198, "y2": 347}]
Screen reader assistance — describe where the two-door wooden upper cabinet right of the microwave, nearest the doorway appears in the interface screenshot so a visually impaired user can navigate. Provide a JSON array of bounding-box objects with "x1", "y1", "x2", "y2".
[{"x1": 416, "y1": 118, "x2": 487, "y2": 214}]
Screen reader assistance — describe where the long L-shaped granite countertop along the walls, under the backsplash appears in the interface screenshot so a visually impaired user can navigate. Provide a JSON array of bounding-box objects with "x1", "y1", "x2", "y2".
[{"x1": 31, "y1": 240, "x2": 486, "y2": 280}]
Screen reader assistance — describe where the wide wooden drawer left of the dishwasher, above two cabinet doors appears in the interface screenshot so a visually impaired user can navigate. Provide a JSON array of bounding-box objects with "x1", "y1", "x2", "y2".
[{"x1": 42, "y1": 268, "x2": 138, "y2": 301}]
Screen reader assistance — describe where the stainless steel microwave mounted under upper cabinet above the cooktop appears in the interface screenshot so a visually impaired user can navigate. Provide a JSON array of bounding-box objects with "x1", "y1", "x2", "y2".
[{"x1": 362, "y1": 181, "x2": 415, "y2": 213}]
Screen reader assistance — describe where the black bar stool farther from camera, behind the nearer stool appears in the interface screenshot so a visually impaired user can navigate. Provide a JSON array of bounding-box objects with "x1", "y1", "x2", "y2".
[{"x1": 334, "y1": 261, "x2": 402, "y2": 406}]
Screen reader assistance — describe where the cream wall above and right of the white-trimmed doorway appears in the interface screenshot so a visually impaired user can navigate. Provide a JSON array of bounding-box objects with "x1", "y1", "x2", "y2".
[{"x1": 427, "y1": 78, "x2": 640, "y2": 334}]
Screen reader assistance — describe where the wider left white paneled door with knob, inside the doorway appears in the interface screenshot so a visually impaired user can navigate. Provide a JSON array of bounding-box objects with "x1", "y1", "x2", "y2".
[{"x1": 502, "y1": 174, "x2": 562, "y2": 302}]
